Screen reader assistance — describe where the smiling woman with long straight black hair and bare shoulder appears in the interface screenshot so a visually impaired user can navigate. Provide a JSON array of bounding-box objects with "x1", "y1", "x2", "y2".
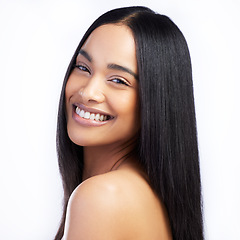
[{"x1": 55, "y1": 7, "x2": 203, "y2": 240}]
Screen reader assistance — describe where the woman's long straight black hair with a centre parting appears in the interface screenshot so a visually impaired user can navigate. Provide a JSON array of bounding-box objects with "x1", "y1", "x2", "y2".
[{"x1": 55, "y1": 7, "x2": 203, "y2": 240}]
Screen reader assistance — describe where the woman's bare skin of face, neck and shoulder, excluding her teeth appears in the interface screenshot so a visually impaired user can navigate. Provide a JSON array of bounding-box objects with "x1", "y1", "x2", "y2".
[{"x1": 63, "y1": 24, "x2": 172, "y2": 240}]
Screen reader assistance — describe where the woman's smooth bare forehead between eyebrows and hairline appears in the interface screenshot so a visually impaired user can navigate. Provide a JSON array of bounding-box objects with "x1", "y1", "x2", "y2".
[{"x1": 81, "y1": 24, "x2": 136, "y2": 70}]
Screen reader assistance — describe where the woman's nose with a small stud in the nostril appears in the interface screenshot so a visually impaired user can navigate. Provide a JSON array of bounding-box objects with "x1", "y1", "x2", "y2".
[{"x1": 79, "y1": 76, "x2": 105, "y2": 104}]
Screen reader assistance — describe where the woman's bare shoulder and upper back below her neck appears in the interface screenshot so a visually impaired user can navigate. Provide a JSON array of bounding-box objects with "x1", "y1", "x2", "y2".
[{"x1": 64, "y1": 170, "x2": 171, "y2": 240}]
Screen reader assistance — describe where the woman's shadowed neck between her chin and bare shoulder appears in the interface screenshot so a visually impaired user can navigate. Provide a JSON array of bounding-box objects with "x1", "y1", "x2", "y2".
[{"x1": 83, "y1": 141, "x2": 136, "y2": 180}]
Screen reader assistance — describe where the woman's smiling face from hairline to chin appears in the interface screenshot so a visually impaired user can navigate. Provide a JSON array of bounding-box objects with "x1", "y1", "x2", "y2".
[{"x1": 65, "y1": 24, "x2": 140, "y2": 146}]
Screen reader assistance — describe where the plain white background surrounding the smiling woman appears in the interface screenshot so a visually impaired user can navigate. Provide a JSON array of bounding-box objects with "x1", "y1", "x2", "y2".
[{"x1": 0, "y1": 0, "x2": 240, "y2": 240}]
